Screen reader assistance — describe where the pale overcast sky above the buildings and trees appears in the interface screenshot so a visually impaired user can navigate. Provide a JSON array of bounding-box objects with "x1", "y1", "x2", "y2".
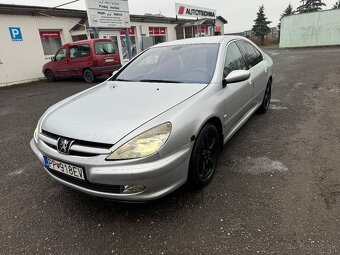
[{"x1": 0, "y1": 0, "x2": 337, "y2": 33}]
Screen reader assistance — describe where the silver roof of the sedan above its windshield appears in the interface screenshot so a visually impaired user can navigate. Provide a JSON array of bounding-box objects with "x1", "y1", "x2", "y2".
[{"x1": 152, "y1": 35, "x2": 245, "y2": 48}]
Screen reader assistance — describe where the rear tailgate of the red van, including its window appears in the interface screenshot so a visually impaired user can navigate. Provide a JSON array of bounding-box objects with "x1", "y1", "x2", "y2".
[{"x1": 94, "y1": 40, "x2": 120, "y2": 70}]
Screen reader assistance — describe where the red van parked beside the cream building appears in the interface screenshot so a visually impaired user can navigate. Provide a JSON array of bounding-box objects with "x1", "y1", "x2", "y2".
[{"x1": 43, "y1": 39, "x2": 121, "y2": 82}]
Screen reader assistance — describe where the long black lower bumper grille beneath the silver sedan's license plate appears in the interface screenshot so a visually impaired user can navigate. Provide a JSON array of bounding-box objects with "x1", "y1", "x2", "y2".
[{"x1": 47, "y1": 169, "x2": 124, "y2": 194}]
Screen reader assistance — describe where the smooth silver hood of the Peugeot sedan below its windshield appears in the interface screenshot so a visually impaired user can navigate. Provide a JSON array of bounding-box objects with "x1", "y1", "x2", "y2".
[{"x1": 42, "y1": 81, "x2": 207, "y2": 144}]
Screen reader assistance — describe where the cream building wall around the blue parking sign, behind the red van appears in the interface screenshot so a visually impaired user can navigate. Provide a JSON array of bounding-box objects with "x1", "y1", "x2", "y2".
[{"x1": 0, "y1": 14, "x2": 80, "y2": 86}]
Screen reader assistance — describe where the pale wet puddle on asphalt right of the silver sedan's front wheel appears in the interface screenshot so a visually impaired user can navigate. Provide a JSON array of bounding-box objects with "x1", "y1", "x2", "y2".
[{"x1": 232, "y1": 156, "x2": 288, "y2": 175}]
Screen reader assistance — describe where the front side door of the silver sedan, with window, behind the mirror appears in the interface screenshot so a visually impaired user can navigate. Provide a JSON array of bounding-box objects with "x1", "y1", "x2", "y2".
[{"x1": 223, "y1": 42, "x2": 253, "y2": 135}]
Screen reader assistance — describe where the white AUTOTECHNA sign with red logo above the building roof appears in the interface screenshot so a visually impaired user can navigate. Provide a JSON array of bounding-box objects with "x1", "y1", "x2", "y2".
[{"x1": 175, "y1": 3, "x2": 216, "y2": 19}]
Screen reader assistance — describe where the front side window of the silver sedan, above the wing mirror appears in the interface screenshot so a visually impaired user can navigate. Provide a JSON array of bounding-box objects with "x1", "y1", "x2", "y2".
[{"x1": 223, "y1": 42, "x2": 247, "y2": 77}]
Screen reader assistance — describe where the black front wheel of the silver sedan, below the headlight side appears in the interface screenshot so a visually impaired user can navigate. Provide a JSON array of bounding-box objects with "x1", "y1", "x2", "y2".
[{"x1": 188, "y1": 123, "x2": 221, "y2": 188}]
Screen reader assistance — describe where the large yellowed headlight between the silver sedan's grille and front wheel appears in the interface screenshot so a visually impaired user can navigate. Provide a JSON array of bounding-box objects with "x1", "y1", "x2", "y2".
[{"x1": 106, "y1": 122, "x2": 171, "y2": 160}]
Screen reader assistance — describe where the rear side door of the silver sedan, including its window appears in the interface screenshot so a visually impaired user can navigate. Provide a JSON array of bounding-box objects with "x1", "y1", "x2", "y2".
[{"x1": 237, "y1": 40, "x2": 267, "y2": 104}]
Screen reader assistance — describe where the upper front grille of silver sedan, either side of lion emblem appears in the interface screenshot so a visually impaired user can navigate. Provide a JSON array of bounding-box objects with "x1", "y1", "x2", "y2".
[{"x1": 41, "y1": 130, "x2": 113, "y2": 157}]
